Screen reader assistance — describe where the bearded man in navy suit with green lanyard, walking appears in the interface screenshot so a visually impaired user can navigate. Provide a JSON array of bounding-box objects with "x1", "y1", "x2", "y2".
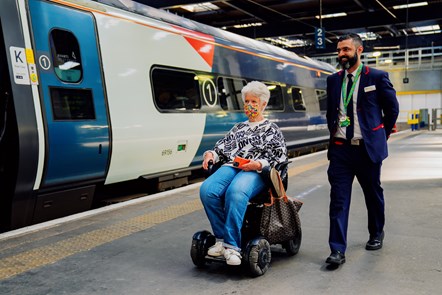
[{"x1": 326, "y1": 34, "x2": 399, "y2": 265}]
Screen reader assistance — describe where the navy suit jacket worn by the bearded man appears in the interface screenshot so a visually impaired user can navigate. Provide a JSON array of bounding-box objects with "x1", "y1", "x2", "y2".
[{"x1": 327, "y1": 66, "x2": 399, "y2": 163}]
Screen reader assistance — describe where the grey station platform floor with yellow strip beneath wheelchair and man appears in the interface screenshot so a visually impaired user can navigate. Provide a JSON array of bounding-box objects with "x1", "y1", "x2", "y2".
[{"x1": 0, "y1": 130, "x2": 442, "y2": 295}]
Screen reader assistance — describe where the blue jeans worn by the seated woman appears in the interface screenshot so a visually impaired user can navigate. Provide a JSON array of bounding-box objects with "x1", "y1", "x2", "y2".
[{"x1": 200, "y1": 166, "x2": 266, "y2": 249}]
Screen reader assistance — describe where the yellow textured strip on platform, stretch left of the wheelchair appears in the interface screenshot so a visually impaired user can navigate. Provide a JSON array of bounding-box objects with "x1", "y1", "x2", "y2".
[{"x1": 0, "y1": 199, "x2": 203, "y2": 280}]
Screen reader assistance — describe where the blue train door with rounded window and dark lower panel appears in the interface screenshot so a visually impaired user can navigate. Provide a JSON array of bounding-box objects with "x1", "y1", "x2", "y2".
[{"x1": 29, "y1": 0, "x2": 110, "y2": 187}]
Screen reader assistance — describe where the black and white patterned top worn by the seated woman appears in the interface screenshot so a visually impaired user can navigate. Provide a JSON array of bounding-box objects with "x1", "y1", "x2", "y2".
[{"x1": 210, "y1": 120, "x2": 287, "y2": 167}]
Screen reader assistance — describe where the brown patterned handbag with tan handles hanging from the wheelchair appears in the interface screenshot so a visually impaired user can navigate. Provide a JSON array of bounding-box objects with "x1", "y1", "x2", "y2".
[{"x1": 260, "y1": 168, "x2": 303, "y2": 244}]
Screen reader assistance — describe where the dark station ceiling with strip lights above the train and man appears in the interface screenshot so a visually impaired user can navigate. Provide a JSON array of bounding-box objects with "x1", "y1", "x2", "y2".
[{"x1": 135, "y1": 0, "x2": 442, "y2": 56}]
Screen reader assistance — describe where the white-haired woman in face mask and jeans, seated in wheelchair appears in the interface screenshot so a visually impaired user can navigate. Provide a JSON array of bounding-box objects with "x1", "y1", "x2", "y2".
[{"x1": 200, "y1": 81, "x2": 287, "y2": 265}]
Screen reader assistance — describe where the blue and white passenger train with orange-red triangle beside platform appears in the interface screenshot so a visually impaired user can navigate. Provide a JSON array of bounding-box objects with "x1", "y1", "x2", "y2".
[{"x1": 0, "y1": 0, "x2": 335, "y2": 232}]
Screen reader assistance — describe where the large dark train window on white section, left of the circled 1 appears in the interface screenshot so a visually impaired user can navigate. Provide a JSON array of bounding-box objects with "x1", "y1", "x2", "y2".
[{"x1": 152, "y1": 68, "x2": 201, "y2": 111}]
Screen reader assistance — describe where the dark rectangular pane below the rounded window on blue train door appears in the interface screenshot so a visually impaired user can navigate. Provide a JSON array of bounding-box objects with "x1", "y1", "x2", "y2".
[{"x1": 50, "y1": 87, "x2": 95, "y2": 121}]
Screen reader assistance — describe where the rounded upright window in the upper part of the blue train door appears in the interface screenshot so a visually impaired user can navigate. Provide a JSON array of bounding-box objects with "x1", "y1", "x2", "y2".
[{"x1": 50, "y1": 29, "x2": 83, "y2": 83}]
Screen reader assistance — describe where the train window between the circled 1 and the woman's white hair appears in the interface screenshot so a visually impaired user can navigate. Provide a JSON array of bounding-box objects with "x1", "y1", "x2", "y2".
[{"x1": 217, "y1": 77, "x2": 246, "y2": 110}]
